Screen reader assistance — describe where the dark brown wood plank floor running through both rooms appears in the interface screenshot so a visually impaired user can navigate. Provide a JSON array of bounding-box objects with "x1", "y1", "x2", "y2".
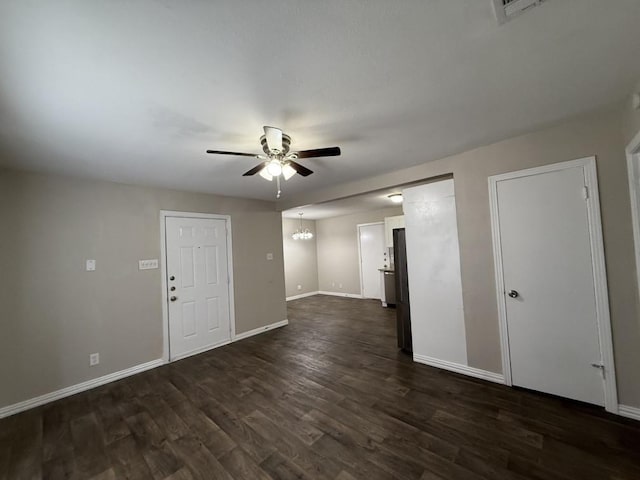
[{"x1": 0, "y1": 296, "x2": 640, "y2": 480}]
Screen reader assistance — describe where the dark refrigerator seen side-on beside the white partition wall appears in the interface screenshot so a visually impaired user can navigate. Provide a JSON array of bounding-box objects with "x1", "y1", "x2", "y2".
[{"x1": 393, "y1": 228, "x2": 413, "y2": 353}]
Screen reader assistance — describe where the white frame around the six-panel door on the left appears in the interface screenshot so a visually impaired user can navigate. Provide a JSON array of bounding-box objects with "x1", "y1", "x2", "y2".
[{"x1": 160, "y1": 210, "x2": 236, "y2": 363}]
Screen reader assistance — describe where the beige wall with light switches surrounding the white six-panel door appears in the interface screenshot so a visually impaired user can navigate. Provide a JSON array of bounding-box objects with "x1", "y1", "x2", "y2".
[{"x1": 0, "y1": 170, "x2": 286, "y2": 407}]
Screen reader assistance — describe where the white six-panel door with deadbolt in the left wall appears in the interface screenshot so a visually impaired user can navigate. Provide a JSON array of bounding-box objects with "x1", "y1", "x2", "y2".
[{"x1": 165, "y1": 217, "x2": 231, "y2": 360}]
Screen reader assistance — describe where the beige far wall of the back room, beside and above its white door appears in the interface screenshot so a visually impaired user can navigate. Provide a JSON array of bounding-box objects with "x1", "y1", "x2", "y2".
[{"x1": 316, "y1": 207, "x2": 402, "y2": 295}]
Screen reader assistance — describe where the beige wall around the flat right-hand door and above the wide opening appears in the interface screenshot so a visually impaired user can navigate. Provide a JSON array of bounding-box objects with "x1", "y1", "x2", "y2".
[{"x1": 281, "y1": 108, "x2": 640, "y2": 407}]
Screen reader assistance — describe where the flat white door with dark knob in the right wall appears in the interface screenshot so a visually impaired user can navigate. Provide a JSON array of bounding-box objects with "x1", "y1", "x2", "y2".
[{"x1": 496, "y1": 162, "x2": 604, "y2": 405}]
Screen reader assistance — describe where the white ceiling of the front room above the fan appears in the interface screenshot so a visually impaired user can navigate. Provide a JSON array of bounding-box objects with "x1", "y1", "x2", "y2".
[{"x1": 0, "y1": 0, "x2": 640, "y2": 199}]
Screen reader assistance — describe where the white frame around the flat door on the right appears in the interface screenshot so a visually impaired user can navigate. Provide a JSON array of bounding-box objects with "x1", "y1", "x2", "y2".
[{"x1": 489, "y1": 157, "x2": 618, "y2": 413}]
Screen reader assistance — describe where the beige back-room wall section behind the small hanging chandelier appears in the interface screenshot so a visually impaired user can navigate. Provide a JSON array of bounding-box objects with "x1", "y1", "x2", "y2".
[{"x1": 282, "y1": 218, "x2": 318, "y2": 297}]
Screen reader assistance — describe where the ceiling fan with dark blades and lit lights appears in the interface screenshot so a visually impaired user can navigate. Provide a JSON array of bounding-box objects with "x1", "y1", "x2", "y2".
[{"x1": 207, "y1": 126, "x2": 340, "y2": 198}]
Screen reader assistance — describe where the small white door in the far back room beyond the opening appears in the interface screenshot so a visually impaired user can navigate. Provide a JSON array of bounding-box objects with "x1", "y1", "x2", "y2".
[{"x1": 358, "y1": 223, "x2": 385, "y2": 299}]
